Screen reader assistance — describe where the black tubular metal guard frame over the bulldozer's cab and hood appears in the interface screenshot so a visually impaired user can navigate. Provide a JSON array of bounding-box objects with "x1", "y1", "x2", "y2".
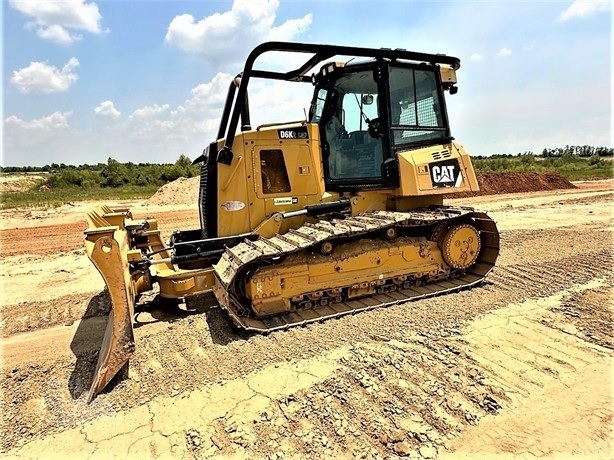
[{"x1": 216, "y1": 42, "x2": 460, "y2": 164}]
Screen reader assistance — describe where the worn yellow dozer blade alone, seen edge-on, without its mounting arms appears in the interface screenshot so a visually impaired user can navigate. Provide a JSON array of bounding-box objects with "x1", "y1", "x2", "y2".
[{"x1": 85, "y1": 209, "x2": 136, "y2": 403}]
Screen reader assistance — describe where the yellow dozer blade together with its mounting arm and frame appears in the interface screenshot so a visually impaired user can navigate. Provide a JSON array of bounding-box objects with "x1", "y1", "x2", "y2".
[{"x1": 85, "y1": 206, "x2": 215, "y2": 402}]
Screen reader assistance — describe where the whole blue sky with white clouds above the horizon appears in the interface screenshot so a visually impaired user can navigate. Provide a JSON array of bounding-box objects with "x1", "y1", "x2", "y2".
[{"x1": 2, "y1": 0, "x2": 613, "y2": 166}]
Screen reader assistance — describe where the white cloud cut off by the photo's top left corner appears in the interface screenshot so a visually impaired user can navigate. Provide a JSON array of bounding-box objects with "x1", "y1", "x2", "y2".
[{"x1": 9, "y1": 0, "x2": 102, "y2": 44}]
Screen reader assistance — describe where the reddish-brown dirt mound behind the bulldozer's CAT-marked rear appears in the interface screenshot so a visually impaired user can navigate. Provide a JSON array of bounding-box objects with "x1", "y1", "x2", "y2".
[{"x1": 458, "y1": 172, "x2": 576, "y2": 198}]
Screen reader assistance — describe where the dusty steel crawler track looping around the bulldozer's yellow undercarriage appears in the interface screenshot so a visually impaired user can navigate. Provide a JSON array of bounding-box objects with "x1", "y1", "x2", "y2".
[{"x1": 214, "y1": 206, "x2": 499, "y2": 332}]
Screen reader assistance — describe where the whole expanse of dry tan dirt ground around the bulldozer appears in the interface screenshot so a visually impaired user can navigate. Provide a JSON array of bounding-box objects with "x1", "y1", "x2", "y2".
[{"x1": 0, "y1": 181, "x2": 614, "y2": 459}]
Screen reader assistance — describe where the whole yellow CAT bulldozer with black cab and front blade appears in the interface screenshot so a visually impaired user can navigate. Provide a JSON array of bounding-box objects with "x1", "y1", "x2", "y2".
[{"x1": 85, "y1": 42, "x2": 499, "y2": 402}]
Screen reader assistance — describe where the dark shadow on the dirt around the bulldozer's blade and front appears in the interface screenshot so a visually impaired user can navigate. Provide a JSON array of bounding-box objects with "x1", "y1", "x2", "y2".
[{"x1": 68, "y1": 288, "x2": 255, "y2": 399}]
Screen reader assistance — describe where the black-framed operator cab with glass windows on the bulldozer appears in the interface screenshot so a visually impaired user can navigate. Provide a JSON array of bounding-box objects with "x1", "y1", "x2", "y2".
[{"x1": 309, "y1": 59, "x2": 452, "y2": 190}]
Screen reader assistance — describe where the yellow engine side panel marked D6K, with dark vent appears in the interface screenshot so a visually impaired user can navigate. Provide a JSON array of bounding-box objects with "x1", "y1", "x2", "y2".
[{"x1": 215, "y1": 123, "x2": 338, "y2": 237}]
